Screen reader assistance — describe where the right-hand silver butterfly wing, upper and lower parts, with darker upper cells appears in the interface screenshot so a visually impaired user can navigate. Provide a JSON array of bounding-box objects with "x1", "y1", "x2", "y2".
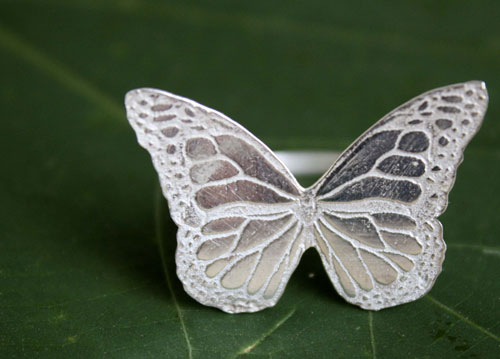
[{"x1": 314, "y1": 81, "x2": 488, "y2": 309}]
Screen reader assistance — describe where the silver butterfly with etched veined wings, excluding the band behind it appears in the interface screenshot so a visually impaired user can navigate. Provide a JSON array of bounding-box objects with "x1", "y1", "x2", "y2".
[{"x1": 125, "y1": 81, "x2": 488, "y2": 313}]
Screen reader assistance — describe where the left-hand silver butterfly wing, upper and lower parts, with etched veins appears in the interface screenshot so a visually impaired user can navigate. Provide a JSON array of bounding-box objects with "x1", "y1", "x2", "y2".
[{"x1": 125, "y1": 89, "x2": 304, "y2": 312}]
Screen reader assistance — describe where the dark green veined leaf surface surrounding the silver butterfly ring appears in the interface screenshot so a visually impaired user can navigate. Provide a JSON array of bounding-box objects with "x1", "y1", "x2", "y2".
[{"x1": 0, "y1": 0, "x2": 500, "y2": 358}]
